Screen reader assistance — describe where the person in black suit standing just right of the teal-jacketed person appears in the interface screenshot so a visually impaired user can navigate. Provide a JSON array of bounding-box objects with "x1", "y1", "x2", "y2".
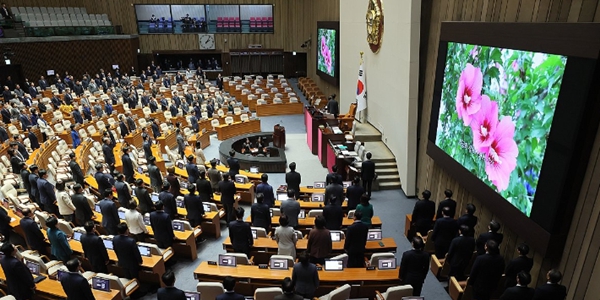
[{"x1": 80, "y1": 221, "x2": 110, "y2": 273}]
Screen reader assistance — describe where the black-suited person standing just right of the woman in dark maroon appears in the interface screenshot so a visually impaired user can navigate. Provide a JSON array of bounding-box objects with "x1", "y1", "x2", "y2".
[{"x1": 344, "y1": 211, "x2": 369, "y2": 268}]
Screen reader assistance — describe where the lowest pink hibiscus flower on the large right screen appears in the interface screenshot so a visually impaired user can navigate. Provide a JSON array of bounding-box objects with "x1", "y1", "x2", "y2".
[{"x1": 485, "y1": 116, "x2": 519, "y2": 192}]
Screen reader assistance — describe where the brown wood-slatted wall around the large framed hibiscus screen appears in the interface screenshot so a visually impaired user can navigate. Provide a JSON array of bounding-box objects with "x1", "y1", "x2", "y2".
[{"x1": 417, "y1": 0, "x2": 600, "y2": 299}]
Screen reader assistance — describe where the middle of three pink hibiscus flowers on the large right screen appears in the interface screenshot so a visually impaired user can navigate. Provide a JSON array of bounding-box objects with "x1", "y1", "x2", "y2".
[{"x1": 471, "y1": 95, "x2": 498, "y2": 153}]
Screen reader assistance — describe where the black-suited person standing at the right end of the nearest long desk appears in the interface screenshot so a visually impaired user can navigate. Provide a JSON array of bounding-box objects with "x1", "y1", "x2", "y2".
[{"x1": 398, "y1": 236, "x2": 430, "y2": 296}]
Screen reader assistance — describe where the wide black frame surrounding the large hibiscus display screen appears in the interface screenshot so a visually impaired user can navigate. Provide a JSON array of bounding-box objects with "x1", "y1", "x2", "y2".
[{"x1": 426, "y1": 22, "x2": 600, "y2": 257}]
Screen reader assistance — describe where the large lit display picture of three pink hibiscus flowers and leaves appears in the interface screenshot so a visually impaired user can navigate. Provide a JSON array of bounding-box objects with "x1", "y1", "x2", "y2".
[{"x1": 435, "y1": 42, "x2": 567, "y2": 216}]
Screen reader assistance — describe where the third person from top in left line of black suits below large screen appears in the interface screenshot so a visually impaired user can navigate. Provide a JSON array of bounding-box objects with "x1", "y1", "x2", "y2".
[{"x1": 446, "y1": 225, "x2": 475, "y2": 281}]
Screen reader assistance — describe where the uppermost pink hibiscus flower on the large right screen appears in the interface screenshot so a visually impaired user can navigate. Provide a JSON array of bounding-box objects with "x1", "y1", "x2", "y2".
[{"x1": 456, "y1": 64, "x2": 483, "y2": 126}]
